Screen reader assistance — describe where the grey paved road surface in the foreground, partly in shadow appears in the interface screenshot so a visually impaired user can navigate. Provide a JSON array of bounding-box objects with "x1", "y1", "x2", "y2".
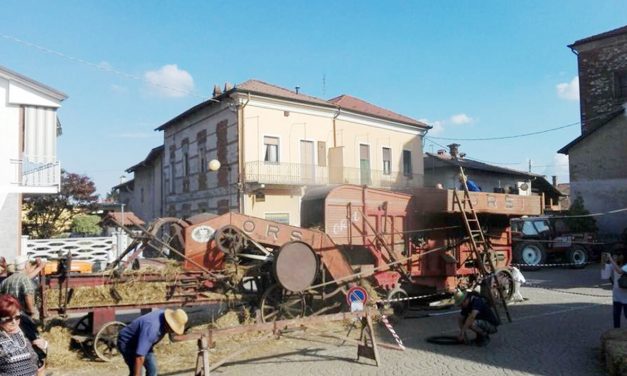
[{"x1": 54, "y1": 265, "x2": 611, "y2": 376}]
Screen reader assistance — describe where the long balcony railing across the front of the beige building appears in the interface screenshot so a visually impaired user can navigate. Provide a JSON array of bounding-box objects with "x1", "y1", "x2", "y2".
[{"x1": 243, "y1": 161, "x2": 423, "y2": 188}]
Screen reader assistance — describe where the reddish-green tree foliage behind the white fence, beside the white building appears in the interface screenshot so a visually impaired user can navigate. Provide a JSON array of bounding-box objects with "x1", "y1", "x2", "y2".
[{"x1": 23, "y1": 171, "x2": 98, "y2": 239}]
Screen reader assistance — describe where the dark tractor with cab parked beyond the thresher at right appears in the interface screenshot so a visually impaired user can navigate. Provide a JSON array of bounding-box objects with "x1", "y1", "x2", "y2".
[{"x1": 511, "y1": 216, "x2": 602, "y2": 269}]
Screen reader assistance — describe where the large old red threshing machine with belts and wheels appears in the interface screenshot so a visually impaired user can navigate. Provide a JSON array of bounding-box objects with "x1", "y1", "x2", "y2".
[{"x1": 42, "y1": 185, "x2": 542, "y2": 359}]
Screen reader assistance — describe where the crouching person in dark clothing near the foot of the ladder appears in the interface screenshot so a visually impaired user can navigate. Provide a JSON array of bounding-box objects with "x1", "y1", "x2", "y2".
[{"x1": 454, "y1": 290, "x2": 499, "y2": 346}]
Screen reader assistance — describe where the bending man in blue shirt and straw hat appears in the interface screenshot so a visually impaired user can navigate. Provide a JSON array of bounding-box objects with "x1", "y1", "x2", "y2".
[{"x1": 117, "y1": 309, "x2": 187, "y2": 376}]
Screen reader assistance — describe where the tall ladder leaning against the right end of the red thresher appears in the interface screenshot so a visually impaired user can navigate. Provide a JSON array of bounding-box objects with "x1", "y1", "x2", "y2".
[{"x1": 453, "y1": 166, "x2": 512, "y2": 322}]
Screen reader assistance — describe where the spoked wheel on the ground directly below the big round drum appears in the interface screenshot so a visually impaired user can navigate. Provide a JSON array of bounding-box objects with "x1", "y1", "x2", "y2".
[{"x1": 261, "y1": 284, "x2": 306, "y2": 322}]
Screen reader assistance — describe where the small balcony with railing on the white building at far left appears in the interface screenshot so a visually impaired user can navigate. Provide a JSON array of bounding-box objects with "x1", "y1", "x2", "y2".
[{"x1": 10, "y1": 156, "x2": 61, "y2": 193}]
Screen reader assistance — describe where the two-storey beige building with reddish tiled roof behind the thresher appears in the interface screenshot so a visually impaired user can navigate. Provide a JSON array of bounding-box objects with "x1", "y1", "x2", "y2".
[{"x1": 130, "y1": 80, "x2": 429, "y2": 225}]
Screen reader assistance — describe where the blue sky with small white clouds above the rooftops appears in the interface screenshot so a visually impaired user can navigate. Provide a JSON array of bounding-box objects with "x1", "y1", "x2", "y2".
[{"x1": 0, "y1": 0, "x2": 627, "y2": 194}]
